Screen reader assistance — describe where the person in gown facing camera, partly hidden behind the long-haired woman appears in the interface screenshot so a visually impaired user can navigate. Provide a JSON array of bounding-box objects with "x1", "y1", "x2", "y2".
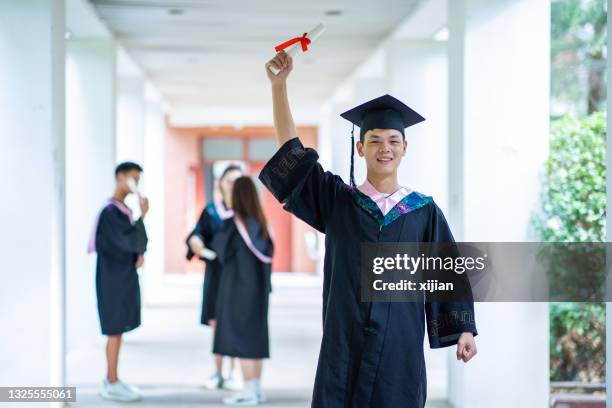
[{"x1": 187, "y1": 165, "x2": 242, "y2": 389}]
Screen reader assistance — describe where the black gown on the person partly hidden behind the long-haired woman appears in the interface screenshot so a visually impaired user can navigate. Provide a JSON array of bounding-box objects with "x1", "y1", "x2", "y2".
[{"x1": 187, "y1": 203, "x2": 227, "y2": 325}]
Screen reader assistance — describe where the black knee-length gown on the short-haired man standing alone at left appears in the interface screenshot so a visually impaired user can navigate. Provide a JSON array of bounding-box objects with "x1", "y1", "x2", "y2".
[{"x1": 96, "y1": 204, "x2": 147, "y2": 335}]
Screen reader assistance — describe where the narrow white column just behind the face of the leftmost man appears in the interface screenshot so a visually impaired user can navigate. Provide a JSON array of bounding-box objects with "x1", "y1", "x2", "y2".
[{"x1": 141, "y1": 86, "x2": 166, "y2": 303}]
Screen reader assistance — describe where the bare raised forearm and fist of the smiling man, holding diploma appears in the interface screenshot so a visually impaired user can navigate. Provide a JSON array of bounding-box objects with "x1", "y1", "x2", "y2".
[{"x1": 266, "y1": 51, "x2": 298, "y2": 146}]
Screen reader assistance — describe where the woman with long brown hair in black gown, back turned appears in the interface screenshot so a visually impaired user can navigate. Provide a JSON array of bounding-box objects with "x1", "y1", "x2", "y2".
[{"x1": 212, "y1": 177, "x2": 274, "y2": 405}]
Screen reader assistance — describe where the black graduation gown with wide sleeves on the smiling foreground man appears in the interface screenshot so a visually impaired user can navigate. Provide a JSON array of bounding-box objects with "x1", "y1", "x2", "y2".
[{"x1": 259, "y1": 138, "x2": 476, "y2": 408}]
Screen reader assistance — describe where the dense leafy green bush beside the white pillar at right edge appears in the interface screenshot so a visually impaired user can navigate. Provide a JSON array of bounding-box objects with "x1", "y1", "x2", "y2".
[{"x1": 534, "y1": 113, "x2": 606, "y2": 382}]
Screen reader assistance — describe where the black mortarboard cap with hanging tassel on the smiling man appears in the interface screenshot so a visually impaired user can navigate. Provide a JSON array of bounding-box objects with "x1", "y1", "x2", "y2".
[{"x1": 340, "y1": 95, "x2": 425, "y2": 187}]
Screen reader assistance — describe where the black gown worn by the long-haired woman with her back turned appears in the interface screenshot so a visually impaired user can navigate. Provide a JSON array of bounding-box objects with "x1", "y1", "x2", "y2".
[{"x1": 212, "y1": 218, "x2": 273, "y2": 359}]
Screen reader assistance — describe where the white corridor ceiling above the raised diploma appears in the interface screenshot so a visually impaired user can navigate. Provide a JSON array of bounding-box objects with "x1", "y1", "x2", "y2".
[{"x1": 90, "y1": 0, "x2": 419, "y2": 113}]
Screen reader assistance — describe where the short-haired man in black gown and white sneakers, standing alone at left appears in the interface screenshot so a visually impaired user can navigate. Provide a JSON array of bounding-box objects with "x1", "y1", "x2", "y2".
[{"x1": 89, "y1": 162, "x2": 149, "y2": 401}]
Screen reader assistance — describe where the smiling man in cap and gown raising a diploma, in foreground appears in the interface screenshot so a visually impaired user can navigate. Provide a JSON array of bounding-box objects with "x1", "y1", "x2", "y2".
[{"x1": 259, "y1": 52, "x2": 477, "y2": 408}]
